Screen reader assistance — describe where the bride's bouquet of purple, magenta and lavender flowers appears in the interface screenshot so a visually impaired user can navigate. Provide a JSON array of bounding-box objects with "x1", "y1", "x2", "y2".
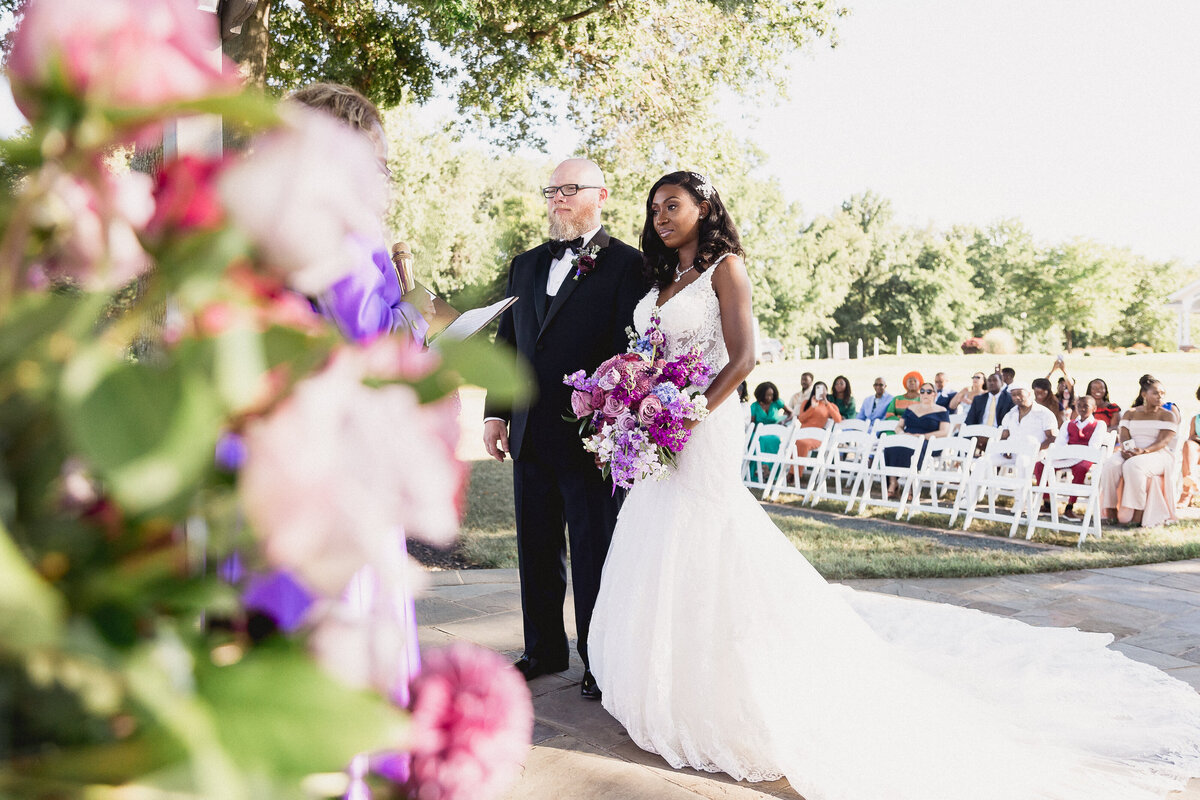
[{"x1": 563, "y1": 313, "x2": 713, "y2": 489}]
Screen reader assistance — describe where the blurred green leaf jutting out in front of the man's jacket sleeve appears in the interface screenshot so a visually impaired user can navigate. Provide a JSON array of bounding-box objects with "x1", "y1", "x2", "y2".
[{"x1": 416, "y1": 338, "x2": 533, "y2": 405}]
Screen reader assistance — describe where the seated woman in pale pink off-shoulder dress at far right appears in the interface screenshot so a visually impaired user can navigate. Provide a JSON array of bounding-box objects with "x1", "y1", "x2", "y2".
[{"x1": 1100, "y1": 380, "x2": 1178, "y2": 527}]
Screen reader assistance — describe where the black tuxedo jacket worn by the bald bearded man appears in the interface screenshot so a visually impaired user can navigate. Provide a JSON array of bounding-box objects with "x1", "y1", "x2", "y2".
[{"x1": 484, "y1": 228, "x2": 647, "y2": 469}]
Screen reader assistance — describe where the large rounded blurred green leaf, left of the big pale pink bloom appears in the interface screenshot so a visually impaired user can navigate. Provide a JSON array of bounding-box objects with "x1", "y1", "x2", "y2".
[{"x1": 60, "y1": 347, "x2": 222, "y2": 513}]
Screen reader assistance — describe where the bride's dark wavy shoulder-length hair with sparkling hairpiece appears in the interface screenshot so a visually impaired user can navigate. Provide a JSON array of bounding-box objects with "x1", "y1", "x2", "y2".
[{"x1": 642, "y1": 172, "x2": 745, "y2": 289}]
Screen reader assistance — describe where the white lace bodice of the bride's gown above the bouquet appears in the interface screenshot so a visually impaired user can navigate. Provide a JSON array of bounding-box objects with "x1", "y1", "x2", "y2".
[{"x1": 634, "y1": 253, "x2": 730, "y2": 374}]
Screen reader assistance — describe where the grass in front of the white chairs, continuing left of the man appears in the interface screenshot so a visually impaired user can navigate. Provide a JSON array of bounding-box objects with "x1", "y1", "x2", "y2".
[{"x1": 458, "y1": 461, "x2": 1200, "y2": 581}]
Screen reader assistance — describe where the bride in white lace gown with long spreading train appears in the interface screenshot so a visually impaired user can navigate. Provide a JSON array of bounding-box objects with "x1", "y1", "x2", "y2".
[{"x1": 588, "y1": 172, "x2": 1200, "y2": 800}]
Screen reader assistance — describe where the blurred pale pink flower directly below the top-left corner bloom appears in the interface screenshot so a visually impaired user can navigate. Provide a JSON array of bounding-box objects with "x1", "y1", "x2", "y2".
[{"x1": 26, "y1": 164, "x2": 154, "y2": 290}]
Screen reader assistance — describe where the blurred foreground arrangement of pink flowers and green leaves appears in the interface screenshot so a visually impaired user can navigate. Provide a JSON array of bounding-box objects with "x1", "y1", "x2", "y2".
[{"x1": 0, "y1": 0, "x2": 533, "y2": 800}]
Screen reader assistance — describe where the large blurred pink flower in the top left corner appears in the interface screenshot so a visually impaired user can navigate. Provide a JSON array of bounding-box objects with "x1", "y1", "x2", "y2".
[{"x1": 8, "y1": 0, "x2": 240, "y2": 119}]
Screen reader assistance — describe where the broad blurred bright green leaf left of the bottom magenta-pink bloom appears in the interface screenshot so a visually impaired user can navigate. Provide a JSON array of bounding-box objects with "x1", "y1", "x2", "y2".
[{"x1": 197, "y1": 640, "x2": 406, "y2": 778}]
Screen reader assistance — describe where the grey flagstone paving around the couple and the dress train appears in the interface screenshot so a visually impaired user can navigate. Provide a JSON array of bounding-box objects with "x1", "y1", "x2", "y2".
[{"x1": 418, "y1": 559, "x2": 1200, "y2": 800}]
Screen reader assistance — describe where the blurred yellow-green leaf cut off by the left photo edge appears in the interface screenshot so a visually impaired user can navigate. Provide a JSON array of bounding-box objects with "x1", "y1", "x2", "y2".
[{"x1": 0, "y1": 522, "x2": 66, "y2": 652}]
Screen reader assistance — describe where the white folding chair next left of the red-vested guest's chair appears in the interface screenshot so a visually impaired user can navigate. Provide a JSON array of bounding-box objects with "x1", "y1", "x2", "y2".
[{"x1": 950, "y1": 437, "x2": 1042, "y2": 536}]
